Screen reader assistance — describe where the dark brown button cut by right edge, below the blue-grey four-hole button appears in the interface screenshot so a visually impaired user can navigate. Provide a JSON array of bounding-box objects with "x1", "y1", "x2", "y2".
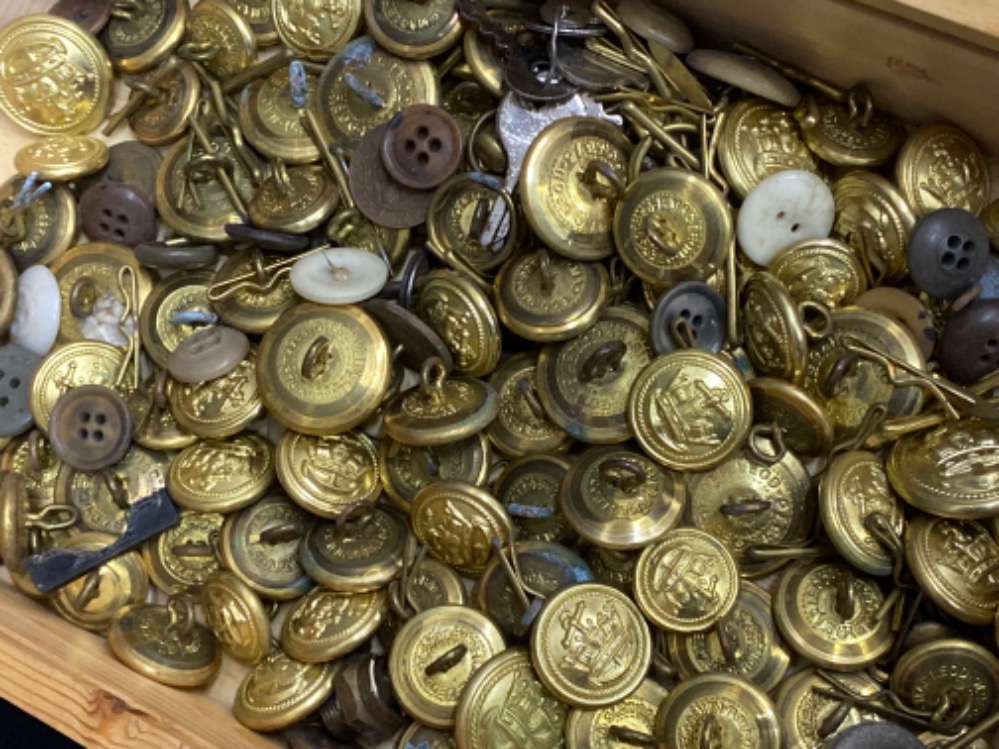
[{"x1": 937, "y1": 299, "x2": 999, "y2": 385}]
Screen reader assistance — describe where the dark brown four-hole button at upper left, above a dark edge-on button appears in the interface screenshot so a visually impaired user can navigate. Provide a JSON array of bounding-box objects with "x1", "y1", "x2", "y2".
[{"x1": 80, "y1": 182, "x2": 156, "y2": 247}]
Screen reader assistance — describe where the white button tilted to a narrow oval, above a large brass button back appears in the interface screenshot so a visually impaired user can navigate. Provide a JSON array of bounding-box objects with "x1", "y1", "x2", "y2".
[{"x1": 291, "y1": 247, "x2": 388, "y2": 304}]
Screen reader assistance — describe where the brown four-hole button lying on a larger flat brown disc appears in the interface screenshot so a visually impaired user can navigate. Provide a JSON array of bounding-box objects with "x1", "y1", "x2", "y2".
[{"x1": 382, "y1": 104, "x2": 461, "y2": 190}]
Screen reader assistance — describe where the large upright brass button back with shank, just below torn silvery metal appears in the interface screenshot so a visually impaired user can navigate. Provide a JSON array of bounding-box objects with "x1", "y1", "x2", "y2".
[{"x1": 520, "y1": 117, "x2": 632, "y2": 261}]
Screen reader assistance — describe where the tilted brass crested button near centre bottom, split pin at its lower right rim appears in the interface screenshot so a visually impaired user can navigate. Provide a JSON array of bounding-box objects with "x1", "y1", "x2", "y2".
[{"x1": 410, "y1": 481, "x2": 514, "y2": 576}]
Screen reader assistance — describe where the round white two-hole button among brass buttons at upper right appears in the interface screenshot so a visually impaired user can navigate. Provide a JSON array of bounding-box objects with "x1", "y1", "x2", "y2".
[{"x1": 736, "y1": 169, "x2": 836, "y2": 267}]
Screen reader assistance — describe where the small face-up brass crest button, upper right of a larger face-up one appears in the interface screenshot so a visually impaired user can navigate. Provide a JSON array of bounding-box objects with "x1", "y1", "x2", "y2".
[{"x1": 634, "y1": 528, "x2": 739, "y2": 632}]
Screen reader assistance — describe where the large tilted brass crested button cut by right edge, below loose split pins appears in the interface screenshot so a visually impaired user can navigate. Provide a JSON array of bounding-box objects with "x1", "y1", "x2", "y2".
[{"x1": 886, "y1": 420, "x2": 999, "y2": 520}]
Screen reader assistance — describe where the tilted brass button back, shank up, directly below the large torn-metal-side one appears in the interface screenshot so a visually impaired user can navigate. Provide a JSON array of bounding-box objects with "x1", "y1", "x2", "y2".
[{"x1": 494, "y1": 248, "x2": 610, "y2": 343}]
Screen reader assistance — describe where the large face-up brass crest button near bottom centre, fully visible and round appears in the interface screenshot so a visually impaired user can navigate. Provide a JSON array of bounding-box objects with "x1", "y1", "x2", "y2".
[{"x1": 531, "y1": 583, "x2": 652, "y2": 710}]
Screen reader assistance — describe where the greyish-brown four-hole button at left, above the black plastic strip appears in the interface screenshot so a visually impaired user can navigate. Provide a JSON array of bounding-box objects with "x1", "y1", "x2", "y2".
[{"x1": 49, "y1": 385, "x2": 132, "y2": 471}]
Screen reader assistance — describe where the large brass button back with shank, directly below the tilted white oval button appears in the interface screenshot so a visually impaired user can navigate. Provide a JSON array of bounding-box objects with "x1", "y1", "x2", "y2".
[{"x1": 257, "y1": 302, "x2": 391, "y2": 435}]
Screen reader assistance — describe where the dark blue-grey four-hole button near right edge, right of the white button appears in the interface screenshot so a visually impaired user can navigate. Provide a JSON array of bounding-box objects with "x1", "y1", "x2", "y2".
[{"x1": 905, "y1": 208, "x2": 989, "y2": 299}]
